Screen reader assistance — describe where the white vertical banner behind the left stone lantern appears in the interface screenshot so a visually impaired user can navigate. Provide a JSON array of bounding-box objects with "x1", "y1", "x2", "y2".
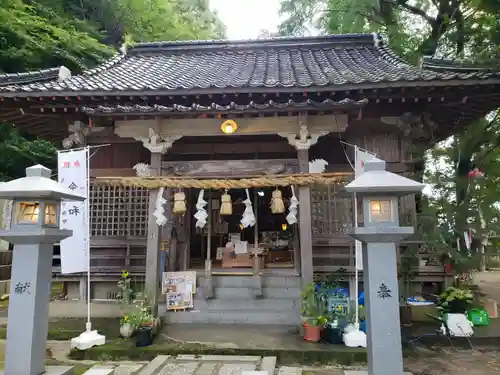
[{"x1": 57, "y1": 148, "x2": 90, "y2": 274}]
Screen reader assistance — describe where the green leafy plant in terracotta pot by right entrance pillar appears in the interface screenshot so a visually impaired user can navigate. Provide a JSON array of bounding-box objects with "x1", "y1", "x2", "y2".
[{"x1": 300, "y1": 283, "x2": 328, "y2": 342}]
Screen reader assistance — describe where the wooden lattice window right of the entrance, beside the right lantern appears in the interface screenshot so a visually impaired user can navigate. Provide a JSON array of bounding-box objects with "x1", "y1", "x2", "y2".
[{"x1": 311, "y1": 185, "x2": 353, "y2": 236}]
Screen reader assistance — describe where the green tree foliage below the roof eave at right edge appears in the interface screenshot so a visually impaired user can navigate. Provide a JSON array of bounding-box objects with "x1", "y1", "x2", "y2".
[{"x1": 424, "y1": 113, "x2": 500, "y2": 273}]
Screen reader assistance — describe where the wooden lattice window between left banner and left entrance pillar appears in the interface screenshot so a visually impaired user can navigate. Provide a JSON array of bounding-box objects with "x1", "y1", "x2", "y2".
[{"x1": 90, "y1": 184, "x2": 149, "y2": 237}]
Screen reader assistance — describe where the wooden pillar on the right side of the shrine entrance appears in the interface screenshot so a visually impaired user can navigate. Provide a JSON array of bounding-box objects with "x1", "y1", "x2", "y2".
[{"x1": 297, "y1": 149, "x2": 313, "y2": 285}]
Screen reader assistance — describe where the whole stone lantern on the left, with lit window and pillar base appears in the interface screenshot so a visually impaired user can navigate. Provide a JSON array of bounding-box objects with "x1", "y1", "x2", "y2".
[{"x1": 0, "y1": 165, "x2": 85, "y2": 375}]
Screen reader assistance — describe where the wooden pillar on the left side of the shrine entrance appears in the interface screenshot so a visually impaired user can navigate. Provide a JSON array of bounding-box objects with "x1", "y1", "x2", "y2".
[{"x1": 145, "y1": 152, "x2": 162, "y2": 316}]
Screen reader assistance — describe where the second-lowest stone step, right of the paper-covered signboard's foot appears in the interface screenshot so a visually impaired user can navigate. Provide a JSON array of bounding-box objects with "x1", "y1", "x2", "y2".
[{"x1": 194, "y1": 296, "x2": 300, "y2": 311}]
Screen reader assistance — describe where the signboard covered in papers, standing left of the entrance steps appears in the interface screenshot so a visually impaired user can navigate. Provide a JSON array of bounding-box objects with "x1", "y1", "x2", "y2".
[{"x1": 162, "y1": 271, "x2": 196, "y2": 310}]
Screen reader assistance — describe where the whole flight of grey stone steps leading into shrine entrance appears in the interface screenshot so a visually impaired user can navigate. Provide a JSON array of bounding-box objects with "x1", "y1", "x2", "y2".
[{"x1": 165, "y1": 276, "x2": 301, "y2": 325}]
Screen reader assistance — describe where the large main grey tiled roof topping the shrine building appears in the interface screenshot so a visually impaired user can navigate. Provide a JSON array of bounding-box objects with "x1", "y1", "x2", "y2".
[{"x1": 0, "y1": 34, "x2": 498, "y2": 95}]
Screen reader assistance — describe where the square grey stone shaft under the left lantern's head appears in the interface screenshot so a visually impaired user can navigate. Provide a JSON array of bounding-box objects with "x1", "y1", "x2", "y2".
[{"x1": 5, "y1": 244, "x2": 53, "y2": 375}]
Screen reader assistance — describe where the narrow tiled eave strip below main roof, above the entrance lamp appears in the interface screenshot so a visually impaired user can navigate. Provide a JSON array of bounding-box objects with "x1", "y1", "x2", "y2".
[{"x1": 81, "y1": 98, "x2": 368, "y2": 115}]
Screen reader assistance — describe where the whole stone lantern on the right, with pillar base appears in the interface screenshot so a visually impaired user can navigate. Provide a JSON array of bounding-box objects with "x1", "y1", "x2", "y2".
[{"x1": 345, "y1": 158, "x2": 425, "y2": 375}]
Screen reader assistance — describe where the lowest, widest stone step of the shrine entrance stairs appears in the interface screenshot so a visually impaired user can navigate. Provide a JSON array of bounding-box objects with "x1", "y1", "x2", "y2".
[{"x1": 165, "y1": 309, "x2": 300, "y2": 325}]
